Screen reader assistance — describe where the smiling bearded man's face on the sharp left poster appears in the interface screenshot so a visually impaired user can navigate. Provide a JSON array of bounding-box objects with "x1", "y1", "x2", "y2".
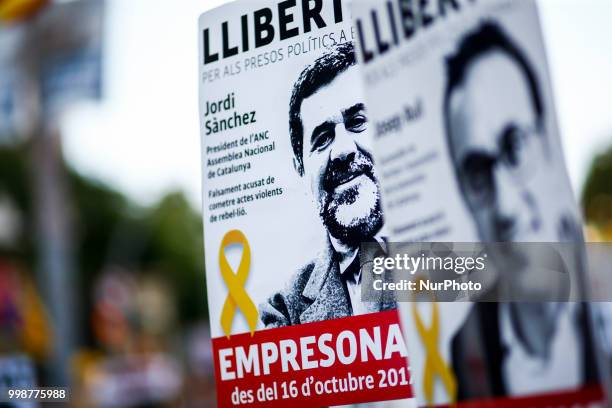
[{"x1": 301, "y1": 67, "x2": 383, "y2": 246}]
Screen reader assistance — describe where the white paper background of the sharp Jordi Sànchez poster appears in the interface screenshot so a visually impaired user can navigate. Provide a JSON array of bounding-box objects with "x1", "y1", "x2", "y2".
[{"x1": 199, "y1": 0, "x2": 360, "y2": 338}]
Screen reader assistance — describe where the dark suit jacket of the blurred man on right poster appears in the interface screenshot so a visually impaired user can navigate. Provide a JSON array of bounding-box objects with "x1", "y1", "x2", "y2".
[{"x1": 451, "y1": 302, "x2": 598, "y2": 401}]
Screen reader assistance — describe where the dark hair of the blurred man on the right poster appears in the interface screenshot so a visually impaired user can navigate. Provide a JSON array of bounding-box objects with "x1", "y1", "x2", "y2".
[{"x1": 444, "y1": 21, "x2": 545, "y2": 137}]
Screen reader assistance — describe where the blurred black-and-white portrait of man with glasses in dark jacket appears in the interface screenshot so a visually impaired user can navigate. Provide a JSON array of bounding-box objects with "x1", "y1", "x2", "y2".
[{"x1": 443, "y1": 21, "x2": 596, "y2": 401}]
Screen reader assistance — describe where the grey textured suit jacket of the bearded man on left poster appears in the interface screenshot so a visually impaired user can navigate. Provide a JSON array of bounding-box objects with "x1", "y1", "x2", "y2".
[{"x1": 259, "y1": 240, "x2": 396, "y2": 328}]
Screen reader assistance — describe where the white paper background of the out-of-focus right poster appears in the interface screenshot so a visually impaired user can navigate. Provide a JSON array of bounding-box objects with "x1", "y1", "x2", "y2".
[{"x1": 353, "y1": 0, "x2": 578, "y2": 405}]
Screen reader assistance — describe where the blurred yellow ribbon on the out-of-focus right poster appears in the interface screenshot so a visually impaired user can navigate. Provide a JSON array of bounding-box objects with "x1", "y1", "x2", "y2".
[{"x1": 412, "y1": 282, "x2": 457, "y2": 405}]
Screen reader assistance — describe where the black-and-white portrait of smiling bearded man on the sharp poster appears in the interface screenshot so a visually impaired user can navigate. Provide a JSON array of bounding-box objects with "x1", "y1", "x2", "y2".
[{"x1": 260, "y1": 43, "x2": 395, "y2": 328}]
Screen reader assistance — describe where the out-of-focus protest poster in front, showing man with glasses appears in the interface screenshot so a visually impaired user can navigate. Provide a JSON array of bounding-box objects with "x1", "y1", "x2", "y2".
[{"x1": 353, "y1": 0, "x2": 601, "y2": 407}]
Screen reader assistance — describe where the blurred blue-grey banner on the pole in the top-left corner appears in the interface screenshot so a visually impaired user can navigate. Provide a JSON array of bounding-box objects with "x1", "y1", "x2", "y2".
[{"x1": 0, "y1": 0, "x2": 104, "y2": 142}]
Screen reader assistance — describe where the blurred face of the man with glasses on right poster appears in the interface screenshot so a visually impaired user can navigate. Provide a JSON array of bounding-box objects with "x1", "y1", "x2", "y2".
[{"x1": 449, "y1": 52, "x2": 544, "y2": 241}]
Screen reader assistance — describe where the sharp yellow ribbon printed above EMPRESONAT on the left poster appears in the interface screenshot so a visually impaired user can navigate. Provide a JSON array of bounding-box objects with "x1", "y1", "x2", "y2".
[{"x1": 219, "y1": 230, "x2": 259, "y2": 338}]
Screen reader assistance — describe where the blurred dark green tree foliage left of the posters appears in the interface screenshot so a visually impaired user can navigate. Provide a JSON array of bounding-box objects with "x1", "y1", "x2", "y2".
[{"x1": 0, "y1": 145, "x2": 207, "y2": 338}]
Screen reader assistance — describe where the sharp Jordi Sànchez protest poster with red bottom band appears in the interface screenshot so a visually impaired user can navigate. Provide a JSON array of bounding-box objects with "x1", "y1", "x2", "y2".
[{"x1": 199, "y1": 0, "x2": 411, "y2": 407}]
